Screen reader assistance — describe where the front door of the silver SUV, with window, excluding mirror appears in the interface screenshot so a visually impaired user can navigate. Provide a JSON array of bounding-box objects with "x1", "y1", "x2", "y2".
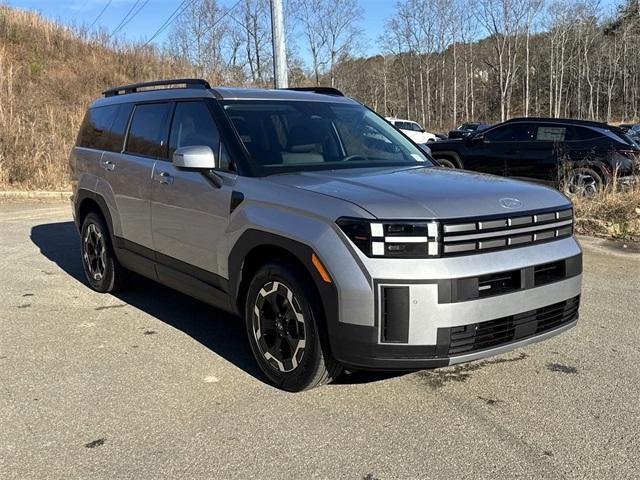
[{"x1": 151, "y1": 100, "x2": 235, "y2": 286}]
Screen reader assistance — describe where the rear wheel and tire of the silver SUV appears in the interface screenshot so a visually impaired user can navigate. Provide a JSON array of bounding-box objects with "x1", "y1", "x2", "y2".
[{"x1": 80, "y1": 212, "x2": 131, "y2": 293}]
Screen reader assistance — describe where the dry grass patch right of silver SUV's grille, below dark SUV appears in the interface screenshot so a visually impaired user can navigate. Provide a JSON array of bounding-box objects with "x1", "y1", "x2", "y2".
[{"x1": 573, "y1": 186, "x2": 640, "y2": 242}]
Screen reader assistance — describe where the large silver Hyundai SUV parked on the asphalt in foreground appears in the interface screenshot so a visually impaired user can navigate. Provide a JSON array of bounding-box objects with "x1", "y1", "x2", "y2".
[{"x1": 70, "y1": 79, "x2": 582, "y2": 391}]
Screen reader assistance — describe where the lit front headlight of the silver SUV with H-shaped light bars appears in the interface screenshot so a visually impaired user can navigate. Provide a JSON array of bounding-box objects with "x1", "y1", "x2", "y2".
[{"x1": 336, "y1": 218, "x2": 440, "y2": 258}]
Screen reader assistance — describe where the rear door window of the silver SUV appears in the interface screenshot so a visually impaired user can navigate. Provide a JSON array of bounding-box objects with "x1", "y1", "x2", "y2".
[{"x1": 127, "y1": 103, "x2": 169, "y2": 157}]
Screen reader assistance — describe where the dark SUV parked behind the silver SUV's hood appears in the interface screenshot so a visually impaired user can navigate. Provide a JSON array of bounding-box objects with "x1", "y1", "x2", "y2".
[{"x1": 430, "y1": 118, "x2": 640, "y2": 194}]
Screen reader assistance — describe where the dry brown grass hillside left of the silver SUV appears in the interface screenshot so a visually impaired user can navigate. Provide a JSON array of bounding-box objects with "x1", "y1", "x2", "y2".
[{"x1": 0, "y1": 6, "x2": 191, "y2": 189}]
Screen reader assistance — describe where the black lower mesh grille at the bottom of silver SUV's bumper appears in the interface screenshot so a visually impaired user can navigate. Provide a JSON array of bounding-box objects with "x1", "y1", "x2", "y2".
[{"x1": 448, "y1": 296, "x2": 580, "y2": 355}]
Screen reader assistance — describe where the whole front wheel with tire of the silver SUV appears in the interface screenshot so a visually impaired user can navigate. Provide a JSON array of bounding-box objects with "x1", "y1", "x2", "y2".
[{"x1": 245, "y1": 261, "x2": 342, "y2": 392}]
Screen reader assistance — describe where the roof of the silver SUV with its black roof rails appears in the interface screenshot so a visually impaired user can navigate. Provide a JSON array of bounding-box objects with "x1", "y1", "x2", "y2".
[{"x1": 91, "y1": 79, "x2": 357, "y2": 107}]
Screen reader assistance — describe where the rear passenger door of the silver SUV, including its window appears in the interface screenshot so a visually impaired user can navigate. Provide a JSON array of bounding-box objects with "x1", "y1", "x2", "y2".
[{"x1": 107, "y1": 102, "x2": 171, "y2": 251}]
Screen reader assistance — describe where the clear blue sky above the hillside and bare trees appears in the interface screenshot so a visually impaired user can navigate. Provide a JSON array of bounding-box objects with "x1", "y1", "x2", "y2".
[{"x1": 8, "y1": 0, "x2": 395, "y2": 56}]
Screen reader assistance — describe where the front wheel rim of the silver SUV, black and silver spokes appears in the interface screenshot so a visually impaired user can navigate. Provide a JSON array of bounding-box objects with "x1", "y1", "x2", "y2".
[{"x1": 253, "y1": 281, "x2": 306, "y2": 372}]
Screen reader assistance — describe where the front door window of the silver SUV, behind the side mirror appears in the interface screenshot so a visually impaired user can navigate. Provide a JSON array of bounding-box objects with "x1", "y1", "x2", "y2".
[{"x1": 169, "y1": 102, "x2": 220, "y2": 158}]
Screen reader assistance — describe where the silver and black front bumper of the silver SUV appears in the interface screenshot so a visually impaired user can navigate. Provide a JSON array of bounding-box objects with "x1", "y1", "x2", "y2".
[{"x1": 329, "y1": 238, "x2": 582, "y2": 370}]
